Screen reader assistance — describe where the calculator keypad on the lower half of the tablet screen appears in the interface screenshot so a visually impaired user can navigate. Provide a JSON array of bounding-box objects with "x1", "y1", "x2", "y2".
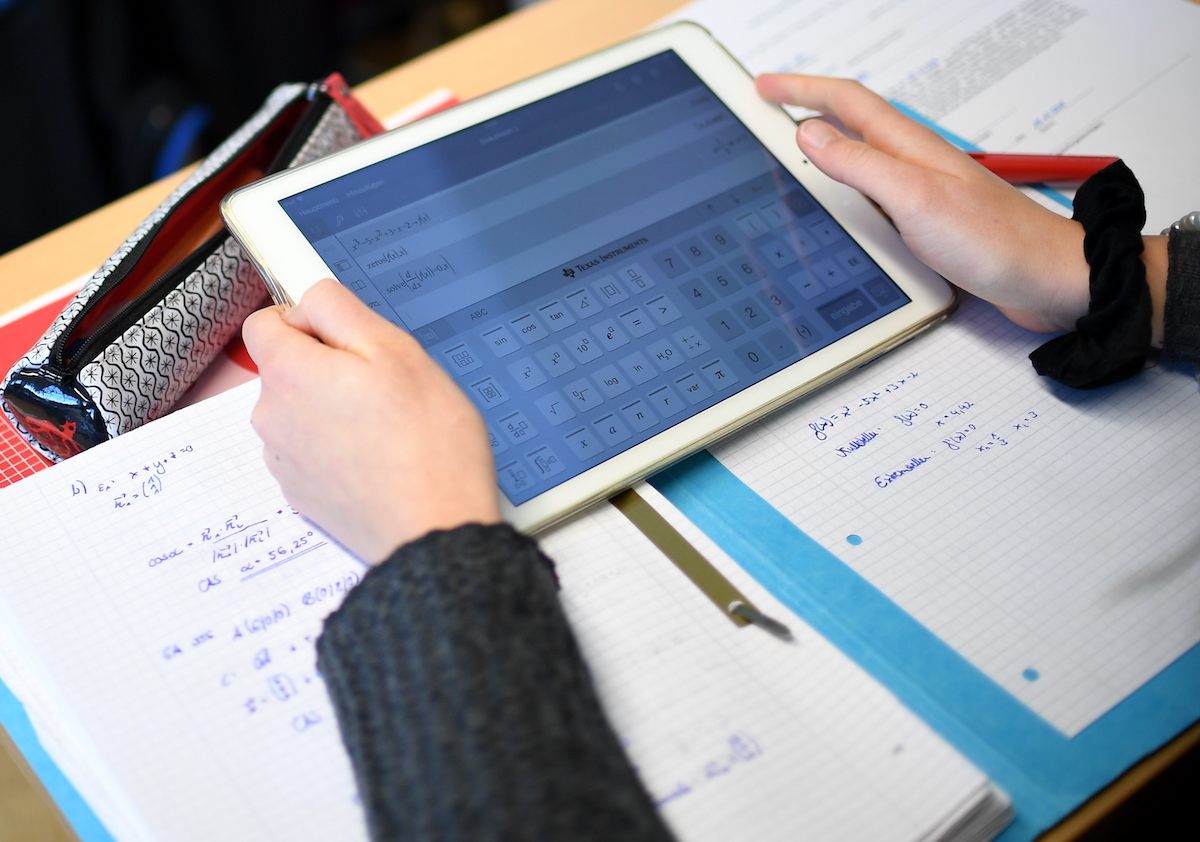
[{"x1": 422, "y1": 170, "x2": 907, "y2": 505}]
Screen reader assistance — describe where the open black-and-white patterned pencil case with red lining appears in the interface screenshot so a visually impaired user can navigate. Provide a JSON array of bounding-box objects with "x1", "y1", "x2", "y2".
[{"x1": 0, "y1": 73, "x2": 383, "y2": 462}]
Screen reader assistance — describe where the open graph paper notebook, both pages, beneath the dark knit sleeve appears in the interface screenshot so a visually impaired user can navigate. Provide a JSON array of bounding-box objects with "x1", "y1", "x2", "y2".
[{"x1": 0, "y1": 383, "x2": 1008, "y2": 842}]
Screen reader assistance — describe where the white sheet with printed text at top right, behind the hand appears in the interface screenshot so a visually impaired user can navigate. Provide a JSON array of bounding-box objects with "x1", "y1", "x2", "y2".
[{"x1": 670, "y1": 0, "x2": 1200, "y2": 234}]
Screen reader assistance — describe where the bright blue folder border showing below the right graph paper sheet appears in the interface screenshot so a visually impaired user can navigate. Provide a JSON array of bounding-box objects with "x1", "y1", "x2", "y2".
[{"x1": 650, "y1": 452, "x2": 1200, "y2": 842}]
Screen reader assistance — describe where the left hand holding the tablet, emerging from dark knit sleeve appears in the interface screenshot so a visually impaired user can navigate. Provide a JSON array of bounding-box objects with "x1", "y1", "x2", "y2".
[{"x1": 242, "y1": 279, "x2": 500, "y2": 563}]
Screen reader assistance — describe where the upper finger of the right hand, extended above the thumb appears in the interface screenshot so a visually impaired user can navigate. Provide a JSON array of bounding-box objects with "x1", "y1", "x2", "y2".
[{"x1": 756, "y1": 73, "x2": 970, "y2": 170}]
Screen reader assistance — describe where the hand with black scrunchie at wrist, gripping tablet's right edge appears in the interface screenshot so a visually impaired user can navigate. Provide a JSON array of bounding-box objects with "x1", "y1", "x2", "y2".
[{"x1": 757, "y1": 73, "x2": 1099, "y2": 331}]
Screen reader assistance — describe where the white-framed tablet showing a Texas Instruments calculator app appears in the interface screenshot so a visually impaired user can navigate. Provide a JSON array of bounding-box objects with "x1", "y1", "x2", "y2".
[{"x1": 222, "y1": 24, "x2": 954, "y2": 531}]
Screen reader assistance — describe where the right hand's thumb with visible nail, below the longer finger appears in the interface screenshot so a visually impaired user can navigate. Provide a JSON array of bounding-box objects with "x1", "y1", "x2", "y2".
[{"x1": 796, "y1": 119, "x2": 943, "y2": 218}]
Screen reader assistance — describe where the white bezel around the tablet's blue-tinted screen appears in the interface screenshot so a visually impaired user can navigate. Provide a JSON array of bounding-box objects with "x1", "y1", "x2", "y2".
[{"x1": 221, "y1": 23, "x2": 956, "y2": 533}]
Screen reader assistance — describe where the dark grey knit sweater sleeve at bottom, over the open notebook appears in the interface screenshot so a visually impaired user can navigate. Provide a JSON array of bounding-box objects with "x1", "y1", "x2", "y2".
[{"x1": 317, "y1": 525, "x2": 671, "y2": 840}]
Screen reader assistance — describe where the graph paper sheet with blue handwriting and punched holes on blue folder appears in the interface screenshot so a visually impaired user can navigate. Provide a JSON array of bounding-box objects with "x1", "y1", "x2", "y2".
[{"x1": 713, "y1": 297, "x2": 1200, "y2": 735}]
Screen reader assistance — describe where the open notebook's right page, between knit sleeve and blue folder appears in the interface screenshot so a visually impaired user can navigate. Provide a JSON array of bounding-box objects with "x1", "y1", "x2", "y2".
[{"x1": 542, "y1": 485, "x2": 989, "y2": 842}]
